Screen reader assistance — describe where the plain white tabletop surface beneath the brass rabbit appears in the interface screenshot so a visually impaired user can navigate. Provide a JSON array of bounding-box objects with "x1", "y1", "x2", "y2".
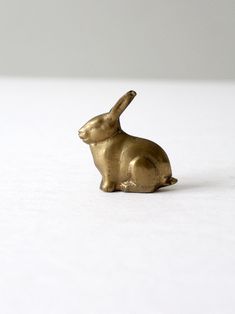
[{"x1": 0, "y1": 78, "x2": 235, "y2": 314}]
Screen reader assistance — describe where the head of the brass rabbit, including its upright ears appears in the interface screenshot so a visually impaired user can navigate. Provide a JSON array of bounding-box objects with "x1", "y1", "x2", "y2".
[{"x1": 79, "y1": 91, "x2": 136, "y2": 144}]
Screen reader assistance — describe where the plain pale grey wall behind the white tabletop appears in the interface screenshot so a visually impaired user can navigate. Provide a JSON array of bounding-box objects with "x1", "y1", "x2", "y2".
[{"x1": 0, "y1": 0, "x2": 235, "y2": 79}]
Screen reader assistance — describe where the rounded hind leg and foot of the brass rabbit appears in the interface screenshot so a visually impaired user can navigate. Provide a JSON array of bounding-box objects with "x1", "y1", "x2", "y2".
[{"x1": 120, "y1": 157, "x2": 157, "y2": 193}]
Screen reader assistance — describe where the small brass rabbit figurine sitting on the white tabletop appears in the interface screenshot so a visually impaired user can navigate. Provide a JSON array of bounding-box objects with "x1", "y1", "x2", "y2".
[{"x1": 79, "y1": 91, "x2": 177, "y2": 192}]
